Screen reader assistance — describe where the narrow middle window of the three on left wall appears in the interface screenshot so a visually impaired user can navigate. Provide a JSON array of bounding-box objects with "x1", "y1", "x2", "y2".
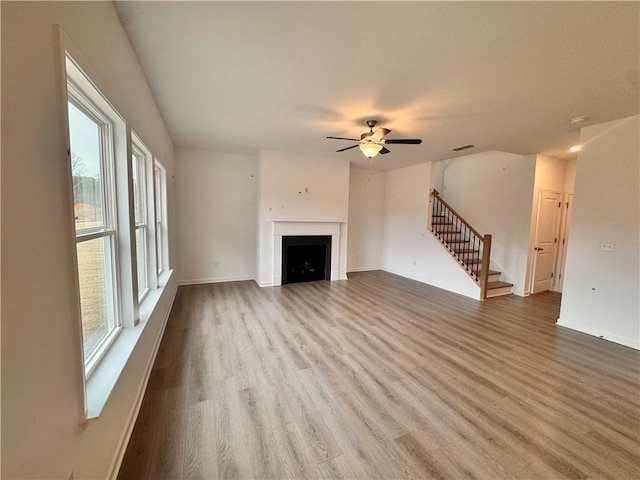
[{"x1": 131, "y1": 136, "x2": 150, "y2": 300}]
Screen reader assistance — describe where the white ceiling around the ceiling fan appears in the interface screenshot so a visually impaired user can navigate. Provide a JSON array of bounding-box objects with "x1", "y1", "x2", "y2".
[{"x1": 116, "y1": 2, "x2": 640, "y2": 170}]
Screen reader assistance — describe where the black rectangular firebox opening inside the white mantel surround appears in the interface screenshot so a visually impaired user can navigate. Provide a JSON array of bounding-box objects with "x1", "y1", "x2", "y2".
[{"x1": 282, "y1": 235, "x2": 331, "y2": 285}]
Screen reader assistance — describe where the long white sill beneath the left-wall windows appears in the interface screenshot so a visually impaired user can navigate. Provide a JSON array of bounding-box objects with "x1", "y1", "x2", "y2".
[{"x1": 83, "y1": 270, "x2": 178, "y2": 422}]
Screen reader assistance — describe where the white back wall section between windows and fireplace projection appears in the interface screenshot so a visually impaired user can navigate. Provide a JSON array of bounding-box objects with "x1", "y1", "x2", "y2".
[{"x1": 176, "y1": 148, "x2": 258, "y2": 283}]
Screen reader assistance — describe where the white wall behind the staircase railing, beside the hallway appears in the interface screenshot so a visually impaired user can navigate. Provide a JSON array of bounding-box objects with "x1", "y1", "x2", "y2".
[{"x1": 442, "y1": 151, "x2": 536, "y2": 295}]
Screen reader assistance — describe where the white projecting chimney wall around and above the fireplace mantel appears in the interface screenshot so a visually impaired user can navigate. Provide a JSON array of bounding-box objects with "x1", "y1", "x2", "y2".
[{"x1": 257, "y1": 150, "x2": 349, "y2": 286}]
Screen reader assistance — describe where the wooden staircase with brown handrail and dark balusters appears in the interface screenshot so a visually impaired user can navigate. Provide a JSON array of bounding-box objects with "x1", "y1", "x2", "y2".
[{"x1": 428, "y1": 189, "x2": 513, "y2": 300}]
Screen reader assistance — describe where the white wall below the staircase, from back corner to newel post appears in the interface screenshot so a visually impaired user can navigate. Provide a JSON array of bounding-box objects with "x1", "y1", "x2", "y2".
[{"x1": 382, "y1": 163, "x2": 480, "y2": 299}]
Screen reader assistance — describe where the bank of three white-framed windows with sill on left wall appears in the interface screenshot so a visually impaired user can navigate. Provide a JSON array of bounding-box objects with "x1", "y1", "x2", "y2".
[{"x1": 62, "y1": 40, "x2": 174, "y2": 421}]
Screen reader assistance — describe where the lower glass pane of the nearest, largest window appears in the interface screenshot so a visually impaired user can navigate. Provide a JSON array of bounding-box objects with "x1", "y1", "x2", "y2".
[{"x1": 76, "y1": 237, "x2": 115, "y2": 359}]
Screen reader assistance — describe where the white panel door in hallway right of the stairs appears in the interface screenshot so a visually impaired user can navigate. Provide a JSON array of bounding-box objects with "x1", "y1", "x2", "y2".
[{"x1": 531, "y1": 190, "x2": 562, "y2": 293}]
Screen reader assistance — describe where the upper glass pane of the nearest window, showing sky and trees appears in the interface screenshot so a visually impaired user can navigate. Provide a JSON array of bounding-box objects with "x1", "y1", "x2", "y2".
[{"x1": 68, "y1": 102, "x2": 105, "y2": 230}]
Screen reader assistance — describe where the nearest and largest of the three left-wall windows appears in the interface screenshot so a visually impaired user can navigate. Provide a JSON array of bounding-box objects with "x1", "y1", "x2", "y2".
[{"x1": 67, "y1": 75, "x2": 122, "y2": 370}]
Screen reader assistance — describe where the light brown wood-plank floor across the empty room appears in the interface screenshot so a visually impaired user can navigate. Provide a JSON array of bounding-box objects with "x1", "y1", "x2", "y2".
[{"x1": 118, "y1": 272, "x2": 640, "y2": 480}]
